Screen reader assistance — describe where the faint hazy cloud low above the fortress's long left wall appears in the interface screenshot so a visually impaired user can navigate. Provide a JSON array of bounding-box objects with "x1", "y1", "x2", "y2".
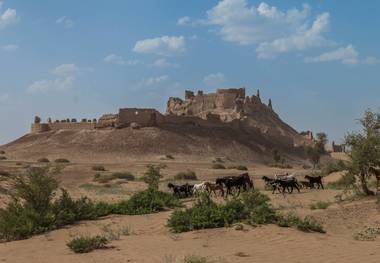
[{"x1": 26, "y1": 64, "x2": 88, "y2": 93}]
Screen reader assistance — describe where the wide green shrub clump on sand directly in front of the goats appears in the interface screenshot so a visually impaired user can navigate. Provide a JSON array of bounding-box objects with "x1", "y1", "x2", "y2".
[{"x1": 168, "y1": 190, "x2": 324, "y2": 233}]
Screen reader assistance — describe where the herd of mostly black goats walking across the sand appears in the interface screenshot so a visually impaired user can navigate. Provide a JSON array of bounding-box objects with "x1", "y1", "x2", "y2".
[{"x1": 168, "y1": 173, "x2": 324, "y2": 197}]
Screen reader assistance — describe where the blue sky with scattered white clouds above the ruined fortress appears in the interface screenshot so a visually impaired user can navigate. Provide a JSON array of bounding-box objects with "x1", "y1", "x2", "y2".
[{"x1": 0, "y1": 0, "x2": 380, "y2": 144}]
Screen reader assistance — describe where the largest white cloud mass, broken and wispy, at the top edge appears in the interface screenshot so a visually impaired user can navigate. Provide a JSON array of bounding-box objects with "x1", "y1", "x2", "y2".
[{"x1": 202, "y1": 0, "x2": 331, "y2": 58}]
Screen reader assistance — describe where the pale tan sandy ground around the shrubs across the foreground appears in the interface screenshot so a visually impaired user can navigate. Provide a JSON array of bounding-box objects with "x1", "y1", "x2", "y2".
[{"x1": 0, "y1": 160, "x2": 380, "y2": 263}]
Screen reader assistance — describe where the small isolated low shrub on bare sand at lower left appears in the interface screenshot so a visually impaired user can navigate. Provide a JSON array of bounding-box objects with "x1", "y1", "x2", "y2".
[{"x1": 67, "y1": 236, "x2": 109, "y2": 253}]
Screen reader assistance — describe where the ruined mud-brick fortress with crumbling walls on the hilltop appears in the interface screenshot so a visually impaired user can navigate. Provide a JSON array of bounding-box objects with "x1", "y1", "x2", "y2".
[{"x1": 31, "y1": 88, "x2": 307, "y2": 146}]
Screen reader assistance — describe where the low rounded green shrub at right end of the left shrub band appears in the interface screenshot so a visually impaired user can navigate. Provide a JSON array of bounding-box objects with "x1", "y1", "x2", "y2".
[{"x1": 114, "y1": 188, "x2": 180, "y2": 215}]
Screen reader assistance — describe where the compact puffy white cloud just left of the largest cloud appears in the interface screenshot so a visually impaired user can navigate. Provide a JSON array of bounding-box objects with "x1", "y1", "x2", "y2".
[{"x1": 133, "y1": 36, "x2": 186, "y2": 56}]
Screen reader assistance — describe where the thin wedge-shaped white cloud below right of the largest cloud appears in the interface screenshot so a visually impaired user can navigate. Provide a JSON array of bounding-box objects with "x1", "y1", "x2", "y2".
[{"x1": 305, "y1": 45, "x2": 359, "y2": 64}]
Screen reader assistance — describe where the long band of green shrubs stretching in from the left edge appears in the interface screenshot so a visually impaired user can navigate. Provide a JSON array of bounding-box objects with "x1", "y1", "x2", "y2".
[{"x1": 0, "y1": 166, "x2": 181, "y2": 241}]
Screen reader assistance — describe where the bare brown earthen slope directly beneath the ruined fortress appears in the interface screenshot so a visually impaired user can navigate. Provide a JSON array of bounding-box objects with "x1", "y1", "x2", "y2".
[{"x1": 0, "y1": 122, "x2": 302, "y2": 162}]
